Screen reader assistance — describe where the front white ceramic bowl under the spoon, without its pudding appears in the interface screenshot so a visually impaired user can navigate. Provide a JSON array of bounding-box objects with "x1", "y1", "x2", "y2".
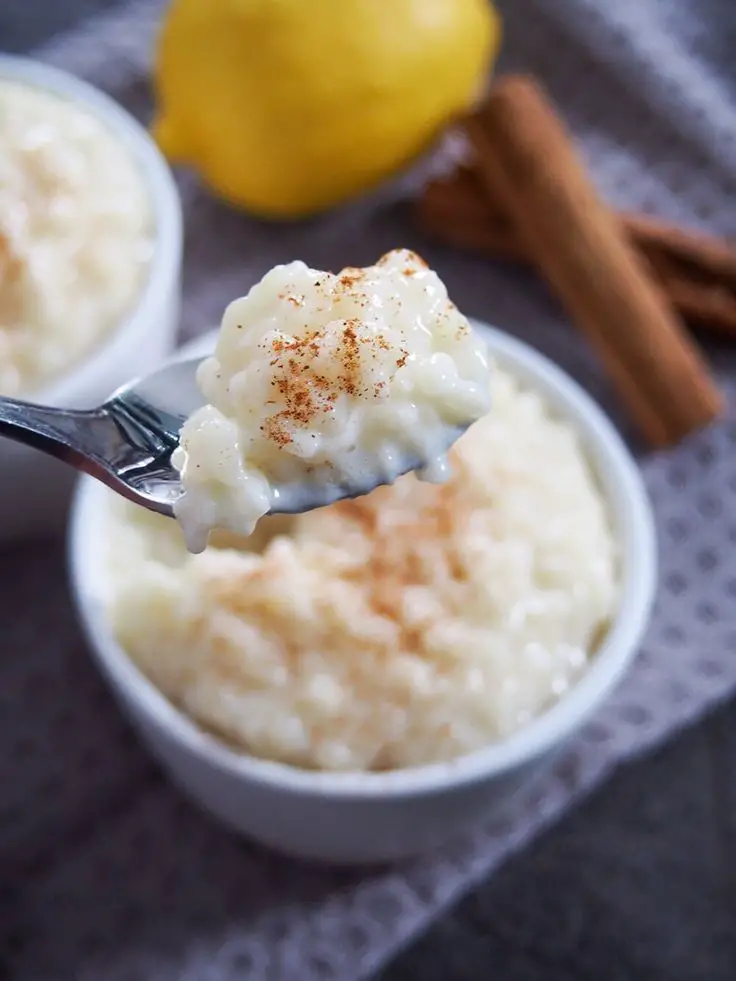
[{"x1": 70, "y1": 320, "x2": 656, "y2": 863}]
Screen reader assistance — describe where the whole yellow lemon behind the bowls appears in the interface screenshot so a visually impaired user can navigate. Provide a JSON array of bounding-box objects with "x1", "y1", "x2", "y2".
[{"x1": 154, "y1": 0, "x2": 500, "y2": 218}]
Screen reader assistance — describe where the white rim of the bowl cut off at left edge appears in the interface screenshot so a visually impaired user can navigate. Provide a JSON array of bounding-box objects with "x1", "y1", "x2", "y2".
[{"x1": 0, "y1": 53, "x2": 184, "y2": 407}]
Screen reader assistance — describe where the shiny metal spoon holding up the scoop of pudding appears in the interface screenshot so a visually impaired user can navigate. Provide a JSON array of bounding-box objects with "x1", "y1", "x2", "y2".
[{"x1": 0, "y1": 358, "x2": 464, "y2": 517}]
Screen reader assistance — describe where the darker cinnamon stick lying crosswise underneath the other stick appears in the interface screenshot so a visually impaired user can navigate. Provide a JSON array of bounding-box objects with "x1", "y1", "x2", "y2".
[{"x1": 417, "y1": 178, "x2": 736, "y2": 337}]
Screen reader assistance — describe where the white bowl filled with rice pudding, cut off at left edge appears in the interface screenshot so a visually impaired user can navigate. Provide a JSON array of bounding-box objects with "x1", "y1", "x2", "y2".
[{"x1": 0, "y1": 56, "x2": 182, "y2": 539}]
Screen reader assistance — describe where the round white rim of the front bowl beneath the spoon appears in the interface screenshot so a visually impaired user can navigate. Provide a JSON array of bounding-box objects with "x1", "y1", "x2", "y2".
[{"x1": 68, "y1": 320, "x2": 657, "y2": 800}]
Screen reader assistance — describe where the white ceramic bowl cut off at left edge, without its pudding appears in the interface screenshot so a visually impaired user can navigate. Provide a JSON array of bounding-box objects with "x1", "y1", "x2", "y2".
[{"x1": 0, "y1": 55, "x2": 182, "y2": 542}]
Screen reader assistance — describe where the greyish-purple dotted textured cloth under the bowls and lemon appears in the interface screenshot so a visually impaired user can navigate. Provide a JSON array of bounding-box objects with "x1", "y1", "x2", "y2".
[{"x1": 0, "y1": 0, "x2": 736, "y2": 981}]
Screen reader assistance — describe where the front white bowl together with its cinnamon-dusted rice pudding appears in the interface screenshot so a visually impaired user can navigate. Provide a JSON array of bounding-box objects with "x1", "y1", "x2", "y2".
[{"x1": 70, "y1": 325, "x2": 656, "y2": 862}]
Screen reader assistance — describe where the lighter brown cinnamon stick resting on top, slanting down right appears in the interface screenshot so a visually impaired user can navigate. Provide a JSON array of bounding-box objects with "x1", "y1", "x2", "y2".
[{"x1": 465, "y1": 76, "x2": 723, "y2": 447}]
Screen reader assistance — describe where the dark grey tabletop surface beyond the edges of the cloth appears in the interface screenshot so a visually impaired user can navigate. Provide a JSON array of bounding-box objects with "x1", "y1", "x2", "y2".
[{"x1": 0, "y1": 0, "x2": 736, "y2": 981}]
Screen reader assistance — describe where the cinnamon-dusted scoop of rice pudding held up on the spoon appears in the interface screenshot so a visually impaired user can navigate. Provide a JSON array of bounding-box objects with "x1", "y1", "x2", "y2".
[{"x1": 172, "y1": 250, "x2": 490, "y2": 552}]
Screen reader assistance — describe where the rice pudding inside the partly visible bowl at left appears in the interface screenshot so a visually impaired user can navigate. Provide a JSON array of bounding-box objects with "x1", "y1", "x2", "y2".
[{"x1": 0, "y1": 78, "x2": 153, "y2": 395}]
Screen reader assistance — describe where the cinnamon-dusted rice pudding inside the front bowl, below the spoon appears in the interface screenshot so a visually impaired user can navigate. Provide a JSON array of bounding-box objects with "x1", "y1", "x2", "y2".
[{"x1": 104, "y1": 366, "x2": 618, "y2": 771}]
